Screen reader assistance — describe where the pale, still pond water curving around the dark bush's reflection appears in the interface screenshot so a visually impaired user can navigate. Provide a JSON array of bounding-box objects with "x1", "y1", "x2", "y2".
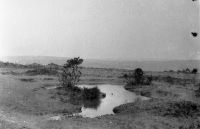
[{"x1": 79, "y1": 84, "x2": 148, "y2": 118}]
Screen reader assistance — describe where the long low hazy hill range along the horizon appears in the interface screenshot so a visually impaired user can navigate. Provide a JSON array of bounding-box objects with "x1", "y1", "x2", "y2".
[{"x1": 2, "y1": 56, "x2": 200, "y2": 71}]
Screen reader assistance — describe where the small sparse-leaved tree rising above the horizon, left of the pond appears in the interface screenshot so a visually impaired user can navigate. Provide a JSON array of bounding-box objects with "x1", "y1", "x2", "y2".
[{"x1": 59, "y1": 57, "x2": 83, "y2": 88}]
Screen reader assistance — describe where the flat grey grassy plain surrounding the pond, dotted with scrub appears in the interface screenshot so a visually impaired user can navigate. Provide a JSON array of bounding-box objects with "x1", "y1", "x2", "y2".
[{"x1": 0, "y1": 68, "x2": 200, "y2": 129}]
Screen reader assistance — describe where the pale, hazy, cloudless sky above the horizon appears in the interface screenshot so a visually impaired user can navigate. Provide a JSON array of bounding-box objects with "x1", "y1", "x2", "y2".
[{"x1": 0, "y1": 0, "x2": 200, "y2": 60}]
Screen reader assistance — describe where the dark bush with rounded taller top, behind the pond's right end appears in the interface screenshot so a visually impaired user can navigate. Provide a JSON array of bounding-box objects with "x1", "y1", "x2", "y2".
[{"x1": 123, "y1": 68, "x2": 153, "y2": 86}]
